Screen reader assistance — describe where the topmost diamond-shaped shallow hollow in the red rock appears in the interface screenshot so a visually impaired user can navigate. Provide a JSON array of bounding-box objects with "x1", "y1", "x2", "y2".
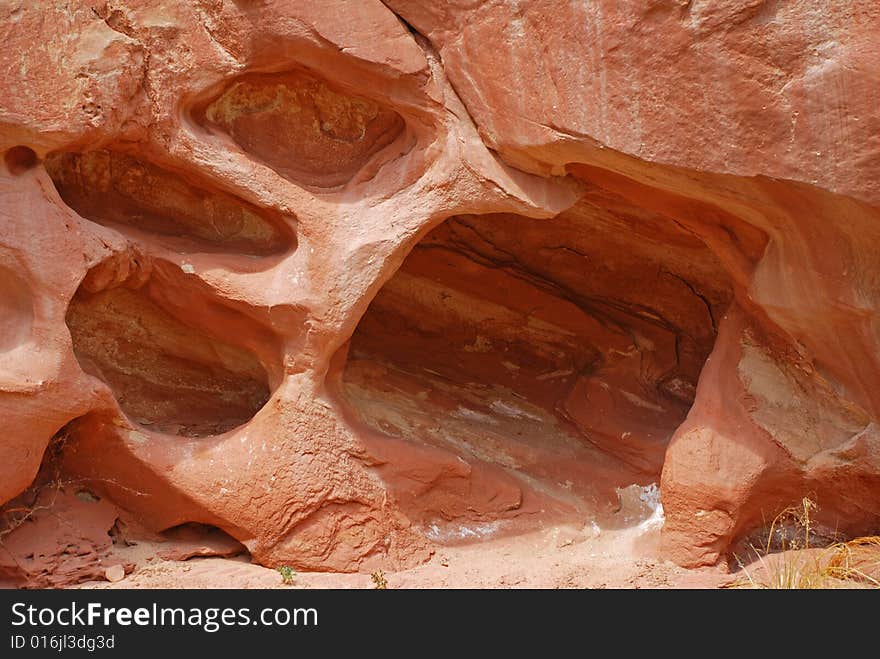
[{"x1": 196, "y1": 71, "x2": 404, "y2": 188}]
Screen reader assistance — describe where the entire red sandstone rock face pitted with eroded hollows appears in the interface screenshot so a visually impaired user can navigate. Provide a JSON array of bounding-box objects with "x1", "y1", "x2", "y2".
[{"x1": 0, "y1": 0, "x2": 880, "y2": 583}]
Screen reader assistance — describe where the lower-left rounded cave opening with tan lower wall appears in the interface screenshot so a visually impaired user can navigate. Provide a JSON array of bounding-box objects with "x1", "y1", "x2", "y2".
[{"x1": 66, "y1": 255, "x2": 277, "y2": 437}]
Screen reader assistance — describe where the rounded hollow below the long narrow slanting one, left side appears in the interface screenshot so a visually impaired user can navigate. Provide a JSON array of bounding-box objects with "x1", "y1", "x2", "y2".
[{"x1": 67, "y1": 262, "x2": 270, "y2": 437}]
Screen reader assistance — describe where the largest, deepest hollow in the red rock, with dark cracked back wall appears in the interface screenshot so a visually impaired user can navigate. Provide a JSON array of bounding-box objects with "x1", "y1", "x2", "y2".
[{"x1": 341, "y1": 195, "x2": 732, "y2": 520}]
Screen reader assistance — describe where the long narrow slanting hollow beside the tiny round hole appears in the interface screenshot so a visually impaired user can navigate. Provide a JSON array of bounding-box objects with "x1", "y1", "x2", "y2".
[{"x1": 45, "y1": 150, "x2": 296, "y2": 256}]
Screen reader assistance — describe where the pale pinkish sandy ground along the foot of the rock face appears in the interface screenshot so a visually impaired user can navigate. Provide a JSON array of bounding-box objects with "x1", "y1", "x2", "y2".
[{"x1": 79, "y1": 520, "x2": 732, "y2": 588}]
